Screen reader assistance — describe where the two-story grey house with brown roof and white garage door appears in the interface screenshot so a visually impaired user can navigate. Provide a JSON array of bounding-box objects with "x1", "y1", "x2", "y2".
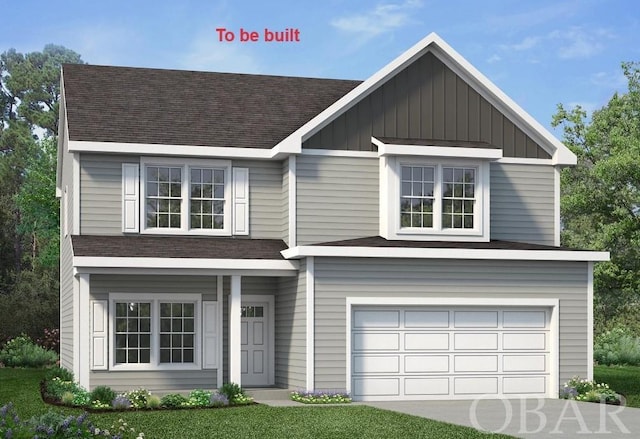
[{"x1": 57, "y1": 34, "x2": 608, "y2": 400}]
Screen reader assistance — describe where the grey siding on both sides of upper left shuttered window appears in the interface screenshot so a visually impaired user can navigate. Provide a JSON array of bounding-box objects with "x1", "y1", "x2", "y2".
[{"x1": 80, "y1": 154, "x2": 282, "y2": 239}]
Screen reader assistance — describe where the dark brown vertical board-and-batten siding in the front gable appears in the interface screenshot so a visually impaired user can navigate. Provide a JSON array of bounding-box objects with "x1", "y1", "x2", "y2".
[{"x1": 302, "y1": 52, "x2": 551, "y2": 159}]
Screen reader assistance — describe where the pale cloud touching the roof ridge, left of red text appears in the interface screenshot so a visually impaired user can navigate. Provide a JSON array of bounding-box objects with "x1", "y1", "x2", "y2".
[{"x1": 179, "y1": 27, "x2": 262, "y2": 73}]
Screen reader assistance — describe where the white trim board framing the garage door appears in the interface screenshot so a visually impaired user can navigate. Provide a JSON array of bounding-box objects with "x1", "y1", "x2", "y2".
[{"x1": 345, "y1": 296, "x2": 560, "y2": 398}]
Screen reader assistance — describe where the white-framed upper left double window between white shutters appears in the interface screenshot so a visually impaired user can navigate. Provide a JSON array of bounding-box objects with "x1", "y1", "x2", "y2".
[{"x1": 141, "y1": 158, "x2": 232, "y2": 235}]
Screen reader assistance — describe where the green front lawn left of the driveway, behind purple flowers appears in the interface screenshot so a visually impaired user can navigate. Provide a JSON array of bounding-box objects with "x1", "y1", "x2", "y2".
[{"x1": 0, "y1": 369, "x2": 509, "y2": 439}]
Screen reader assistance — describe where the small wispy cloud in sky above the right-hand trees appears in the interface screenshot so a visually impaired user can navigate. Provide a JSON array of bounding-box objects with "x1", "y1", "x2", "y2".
[{"x1": 548, "y1": 26, "x2": 613, "y2": 59}]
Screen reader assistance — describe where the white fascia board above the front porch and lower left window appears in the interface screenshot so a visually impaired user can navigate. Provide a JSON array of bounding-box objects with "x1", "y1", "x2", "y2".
[{"x1": 73, "y1": 256, "x2": 298, "y2": 271}]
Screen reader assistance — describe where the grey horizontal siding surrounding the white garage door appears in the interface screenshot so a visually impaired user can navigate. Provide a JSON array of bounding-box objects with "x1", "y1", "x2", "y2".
[{"x1": 315, "y1": 257, "x2": 590, "y2": 389}]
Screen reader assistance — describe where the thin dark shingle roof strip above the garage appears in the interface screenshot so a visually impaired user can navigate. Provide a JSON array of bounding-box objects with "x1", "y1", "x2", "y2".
[{"x1": 313, "y1": 236, "x2": 576, "y2": 251}]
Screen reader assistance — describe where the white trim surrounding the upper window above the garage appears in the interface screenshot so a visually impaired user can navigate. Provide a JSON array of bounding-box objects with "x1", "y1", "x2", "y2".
[{"x1": 380, "y1": 156, "x2": 490, "y2": 242}]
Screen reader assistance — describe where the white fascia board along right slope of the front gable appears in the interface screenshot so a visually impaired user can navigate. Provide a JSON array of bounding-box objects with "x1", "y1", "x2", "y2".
[{"x1": 433, "y1": 35, "x2": 577, "y2": 165}]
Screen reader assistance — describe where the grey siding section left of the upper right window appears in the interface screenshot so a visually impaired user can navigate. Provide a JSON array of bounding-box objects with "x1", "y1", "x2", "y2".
[{"x1": 296, "y1": 155, "x2": 380, "y2": 245}]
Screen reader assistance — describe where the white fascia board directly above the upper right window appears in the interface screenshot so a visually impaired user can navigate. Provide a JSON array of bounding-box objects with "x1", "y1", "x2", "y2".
[{"x1": 371, "y1": 137, "x2": 502, "y2": 160}]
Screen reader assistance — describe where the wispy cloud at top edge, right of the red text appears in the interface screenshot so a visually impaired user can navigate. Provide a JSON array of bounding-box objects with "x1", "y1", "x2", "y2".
[{"x1": 330, "y1": 0, "x2": 422, "y2": 44}]
